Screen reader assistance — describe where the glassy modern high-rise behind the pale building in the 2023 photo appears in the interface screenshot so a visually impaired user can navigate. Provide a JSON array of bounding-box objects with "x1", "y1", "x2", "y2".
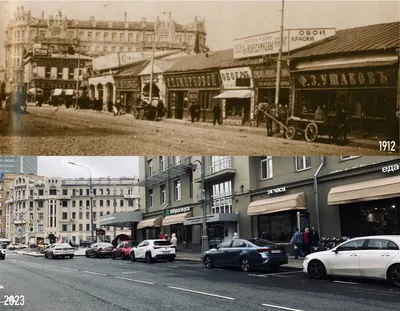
[{"x1": 0, "y1": 156, "x2": 38, "y2": 175}]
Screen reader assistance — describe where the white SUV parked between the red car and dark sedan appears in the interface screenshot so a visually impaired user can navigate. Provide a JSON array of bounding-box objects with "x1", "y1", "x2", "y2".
[{"x1": 129, "y1": 240, "x2": 176, "y2": 263}]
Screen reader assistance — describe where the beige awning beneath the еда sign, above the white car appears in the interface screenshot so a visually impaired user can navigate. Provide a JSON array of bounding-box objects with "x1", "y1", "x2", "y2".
[{"x1": 328, "y1": 176, "x2": 400, "y2": 205}]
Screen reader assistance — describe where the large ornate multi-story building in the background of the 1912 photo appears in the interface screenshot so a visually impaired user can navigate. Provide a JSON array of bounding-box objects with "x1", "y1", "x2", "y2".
[{"x1": 4, "y1": 6, "x2": 208, "y2": 91}]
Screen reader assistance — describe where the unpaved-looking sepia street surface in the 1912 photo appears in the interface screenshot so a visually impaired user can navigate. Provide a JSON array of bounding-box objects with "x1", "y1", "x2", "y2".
[{"x1": 0, "y1": 105, "x2": 388, "y2": 156}]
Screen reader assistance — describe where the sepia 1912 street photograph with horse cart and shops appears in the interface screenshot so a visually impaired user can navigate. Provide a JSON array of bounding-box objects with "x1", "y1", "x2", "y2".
[{"x1": 0, "y1": 1, "x2": 400, "y2": 155}]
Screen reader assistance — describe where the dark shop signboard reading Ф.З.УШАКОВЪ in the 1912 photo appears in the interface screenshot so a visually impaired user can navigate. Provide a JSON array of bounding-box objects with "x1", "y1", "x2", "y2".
[{"x1": 294, "y1": 68, "x2": 396, "y2": 89}]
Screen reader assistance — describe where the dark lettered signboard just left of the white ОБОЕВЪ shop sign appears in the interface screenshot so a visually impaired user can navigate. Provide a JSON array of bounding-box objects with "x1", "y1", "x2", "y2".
[{"x1": 165, "y1": 73, "x2": 220, "y2": 89}]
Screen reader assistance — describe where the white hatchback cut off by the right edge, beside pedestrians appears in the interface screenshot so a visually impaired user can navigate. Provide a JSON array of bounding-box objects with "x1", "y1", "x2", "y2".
[{"x1": 303, "y1": 235, "x2": 400, "y2": 287}]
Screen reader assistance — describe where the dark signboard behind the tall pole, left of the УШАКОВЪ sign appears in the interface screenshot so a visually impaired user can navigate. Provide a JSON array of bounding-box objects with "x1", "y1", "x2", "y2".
[{"x1": 252, "y1": 63, "x2": 290, "y2": 88}]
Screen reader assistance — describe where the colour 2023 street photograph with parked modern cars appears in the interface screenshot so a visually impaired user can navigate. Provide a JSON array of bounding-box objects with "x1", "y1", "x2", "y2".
[{"x1": 0, "y1": 156, "x2": 400, "y2": 311}]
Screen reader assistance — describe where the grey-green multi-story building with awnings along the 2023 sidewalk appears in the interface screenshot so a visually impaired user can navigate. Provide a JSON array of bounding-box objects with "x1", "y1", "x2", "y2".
[{"x1": 137, "y1": 156, "x2": 400, "y2": 250}]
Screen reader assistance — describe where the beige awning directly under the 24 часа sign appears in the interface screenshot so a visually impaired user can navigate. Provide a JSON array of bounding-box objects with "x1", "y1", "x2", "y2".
[{"x1": 247, "y1": 192, "x2": 306, "y2": 216}]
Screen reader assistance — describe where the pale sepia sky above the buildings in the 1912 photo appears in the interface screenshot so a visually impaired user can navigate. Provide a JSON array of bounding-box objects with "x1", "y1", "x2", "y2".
[{"x1": 0, "y1": 0, "x2": 400, "y2": 64}]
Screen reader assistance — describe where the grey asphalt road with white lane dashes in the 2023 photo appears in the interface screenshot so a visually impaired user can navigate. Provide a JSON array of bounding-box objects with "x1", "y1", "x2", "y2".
[{"x1": 0, "y1": 254, "x2": 400, "y2": 311}]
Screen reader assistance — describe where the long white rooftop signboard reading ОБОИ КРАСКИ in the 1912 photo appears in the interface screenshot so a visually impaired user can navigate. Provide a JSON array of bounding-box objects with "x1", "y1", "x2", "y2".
[{"x1": 233, "y1": 28, "x2": 336, "y2": 59}]
